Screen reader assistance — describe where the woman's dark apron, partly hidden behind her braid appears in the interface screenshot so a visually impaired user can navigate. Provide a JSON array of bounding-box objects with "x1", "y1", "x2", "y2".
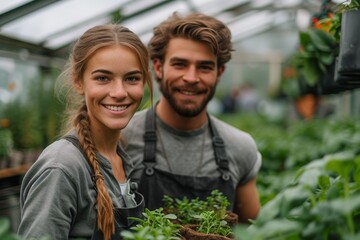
[{"x1": 63, "y1": 135, "x2": 145, "y2": 240}]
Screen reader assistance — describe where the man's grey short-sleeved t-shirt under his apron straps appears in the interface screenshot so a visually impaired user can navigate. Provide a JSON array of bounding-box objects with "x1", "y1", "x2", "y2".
[{"x1": 122, "y1": 110, "x2": 261, "y2": 188}]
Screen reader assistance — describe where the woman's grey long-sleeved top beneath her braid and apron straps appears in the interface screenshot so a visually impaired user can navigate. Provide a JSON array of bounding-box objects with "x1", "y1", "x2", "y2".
[{"x1": 18, "y1": 134, "x2": 133, "y2": 240}]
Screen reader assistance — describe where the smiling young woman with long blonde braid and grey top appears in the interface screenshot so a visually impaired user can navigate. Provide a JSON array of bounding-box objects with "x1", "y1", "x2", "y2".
[{"x1": 18, "y1": 25, "x2": 152, "y2": 240}]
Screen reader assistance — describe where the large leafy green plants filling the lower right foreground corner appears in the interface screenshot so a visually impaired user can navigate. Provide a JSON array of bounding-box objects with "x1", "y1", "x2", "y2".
[{"x1": 234, "y1": 152, "x2": 360, "y2": 240}]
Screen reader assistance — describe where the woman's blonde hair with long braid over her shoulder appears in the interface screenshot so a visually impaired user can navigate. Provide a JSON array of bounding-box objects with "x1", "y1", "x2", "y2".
[{"x1": 56, "y1": 24, "x2": 152, "y2": 239}]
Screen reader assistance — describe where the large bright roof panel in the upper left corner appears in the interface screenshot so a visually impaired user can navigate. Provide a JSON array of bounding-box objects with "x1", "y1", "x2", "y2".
[{"x1": 2, "y1": 0, "x2": 127, "y2": 44}]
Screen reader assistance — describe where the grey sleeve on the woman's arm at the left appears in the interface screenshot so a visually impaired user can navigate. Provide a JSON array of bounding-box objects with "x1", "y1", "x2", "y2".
[{"x1": 18, "y1": 167, "x2": 77, "y2": 240}]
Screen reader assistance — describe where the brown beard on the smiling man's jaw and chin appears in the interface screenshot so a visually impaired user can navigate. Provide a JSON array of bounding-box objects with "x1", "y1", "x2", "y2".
[{"x1": 159, "y1": 80, "x2": 216, "y2": 117}]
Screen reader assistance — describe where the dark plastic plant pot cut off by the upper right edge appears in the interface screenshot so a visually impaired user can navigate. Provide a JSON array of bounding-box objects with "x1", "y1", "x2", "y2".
[{"x1": 337, "y1": 10, "x2": 360, "y2": 84}]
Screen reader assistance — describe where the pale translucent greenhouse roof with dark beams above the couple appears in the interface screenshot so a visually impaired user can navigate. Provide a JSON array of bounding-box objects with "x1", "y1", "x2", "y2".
[{"x1": 0, "y1": 0, "x2": 344, "y2": 65}]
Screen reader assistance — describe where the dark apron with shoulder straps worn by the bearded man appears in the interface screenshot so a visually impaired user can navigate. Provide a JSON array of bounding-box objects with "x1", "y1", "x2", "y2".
[{"x1": 139, "y1": 108, "x2": 235, "y2": 210}]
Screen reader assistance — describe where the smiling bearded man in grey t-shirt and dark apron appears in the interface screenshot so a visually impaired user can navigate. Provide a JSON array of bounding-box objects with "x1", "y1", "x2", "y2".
[{"x1": 123, "y1": 13, "x2": 261, "y2": 223}]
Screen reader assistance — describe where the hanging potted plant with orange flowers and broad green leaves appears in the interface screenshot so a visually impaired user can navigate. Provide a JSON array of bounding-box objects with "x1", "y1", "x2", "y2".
[{"x1": 295, "y1": 0, "x2": 359, "y2": 95}]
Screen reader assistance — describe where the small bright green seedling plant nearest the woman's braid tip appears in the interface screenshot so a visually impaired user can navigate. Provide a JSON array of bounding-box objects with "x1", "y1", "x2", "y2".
[{"x1": 121, "y1": 208, "x2": 181, "y2": 240}]
